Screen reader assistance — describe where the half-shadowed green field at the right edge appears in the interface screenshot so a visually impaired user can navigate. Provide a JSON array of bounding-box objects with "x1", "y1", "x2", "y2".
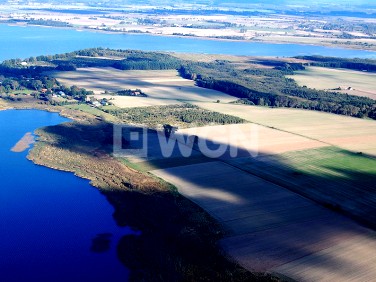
[{"x1": 229, "y1": 146, "x2": 376, "y2": 226}]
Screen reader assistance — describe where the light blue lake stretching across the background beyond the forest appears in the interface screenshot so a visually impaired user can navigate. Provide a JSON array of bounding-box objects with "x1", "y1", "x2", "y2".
[{"x1": 0, "y1": 24, "x2": 376, "y2": 61}]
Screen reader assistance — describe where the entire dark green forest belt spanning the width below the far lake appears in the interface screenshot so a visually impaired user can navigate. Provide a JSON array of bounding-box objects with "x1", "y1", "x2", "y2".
[{"x1": 0, "y1": 48, "x2": 376, "y2": 119}]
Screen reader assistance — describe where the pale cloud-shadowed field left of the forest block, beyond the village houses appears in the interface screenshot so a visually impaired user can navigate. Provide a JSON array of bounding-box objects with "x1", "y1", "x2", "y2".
[{"x1": 53, "y1": 68, "x2": 236, "y2": 107}]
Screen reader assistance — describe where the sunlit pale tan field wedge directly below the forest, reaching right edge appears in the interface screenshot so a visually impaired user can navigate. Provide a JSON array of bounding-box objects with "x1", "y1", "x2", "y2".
[{"x1": 195, "y1": 103, "x2": 376, "y2": 156}]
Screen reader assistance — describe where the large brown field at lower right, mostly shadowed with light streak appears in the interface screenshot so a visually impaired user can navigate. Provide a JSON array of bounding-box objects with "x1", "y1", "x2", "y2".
[{"x1": 152, "y1": 162, "x2": 376, "y2": 281}]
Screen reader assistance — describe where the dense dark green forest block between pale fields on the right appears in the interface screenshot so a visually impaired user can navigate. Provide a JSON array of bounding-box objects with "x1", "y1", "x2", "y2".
[{"x1": 179, "y1": 61, "x2": 376, "y2": 119}]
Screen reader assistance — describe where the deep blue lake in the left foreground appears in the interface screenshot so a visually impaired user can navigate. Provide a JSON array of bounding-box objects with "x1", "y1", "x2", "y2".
[{"x1": 0, "y1": 110, "x2": 133, "y2": 282}]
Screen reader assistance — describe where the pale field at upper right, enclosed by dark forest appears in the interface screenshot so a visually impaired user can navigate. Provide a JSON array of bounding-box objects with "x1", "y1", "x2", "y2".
[{"x1": 288, "y1": 67, "x2": 376, "y2": 99}]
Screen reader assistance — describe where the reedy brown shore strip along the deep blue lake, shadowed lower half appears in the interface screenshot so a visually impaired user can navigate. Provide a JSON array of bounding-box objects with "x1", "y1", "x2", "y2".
[{"x1": 1, "y1": 101, "x2": 273, "y2": 281}]
